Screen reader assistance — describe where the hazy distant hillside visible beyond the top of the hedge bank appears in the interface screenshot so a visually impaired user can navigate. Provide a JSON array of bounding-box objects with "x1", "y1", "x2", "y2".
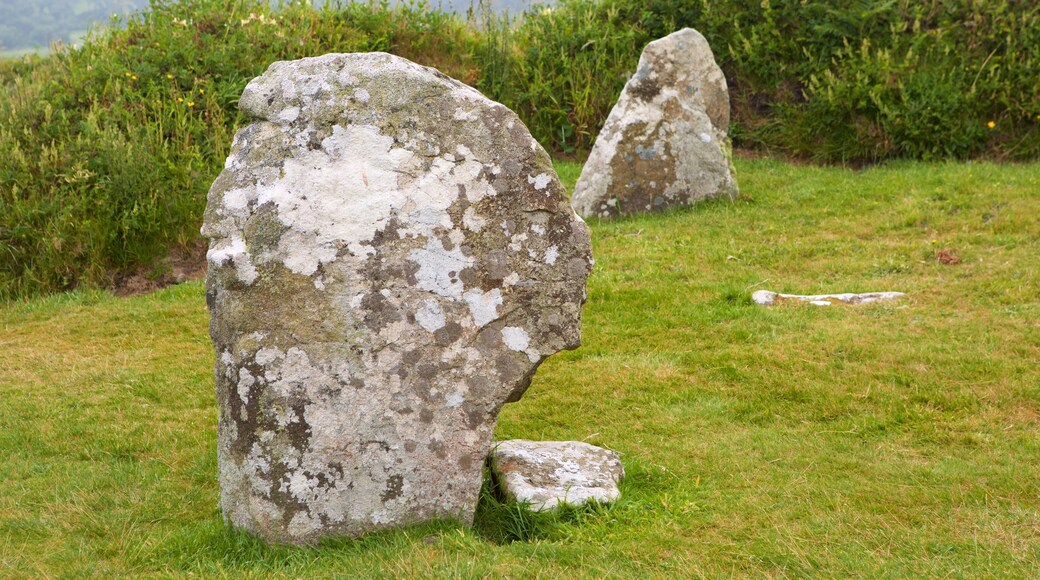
[{"x1": 0, "y1": 0, "x2": 552, "y2": 52}]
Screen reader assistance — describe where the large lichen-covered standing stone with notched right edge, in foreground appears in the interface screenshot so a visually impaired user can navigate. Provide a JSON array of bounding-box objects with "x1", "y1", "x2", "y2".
[{"x1": 203, "y1": 53, "x2": 592, "y2": 544}]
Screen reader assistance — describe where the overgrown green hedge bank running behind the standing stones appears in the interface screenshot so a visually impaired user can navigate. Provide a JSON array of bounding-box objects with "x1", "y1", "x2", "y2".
[{"x1": 0, "y1": 0, "x2": 1040, "y2": 298}]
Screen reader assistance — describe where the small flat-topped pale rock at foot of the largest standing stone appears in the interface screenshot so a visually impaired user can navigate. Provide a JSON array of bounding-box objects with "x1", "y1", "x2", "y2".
[{"x1": 491, "y1": 439, "x2": 625, "y2": 511}]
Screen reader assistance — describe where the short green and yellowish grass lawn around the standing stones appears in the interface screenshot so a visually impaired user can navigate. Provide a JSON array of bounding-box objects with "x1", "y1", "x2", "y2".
[{"x1": 0, "y1": 159, "x2": 1040, "y2": 578}]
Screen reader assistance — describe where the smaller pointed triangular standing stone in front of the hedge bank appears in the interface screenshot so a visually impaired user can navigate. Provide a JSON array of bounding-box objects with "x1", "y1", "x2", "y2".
[{"x1": 572, "y1": 28, "x2": 737, "y2": 218}]
